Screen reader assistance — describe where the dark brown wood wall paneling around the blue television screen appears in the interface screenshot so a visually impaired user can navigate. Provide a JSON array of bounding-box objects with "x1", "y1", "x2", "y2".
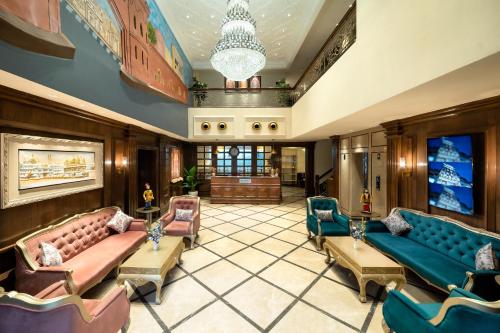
[{"x1": 382, "y1": 96, "x2": 500, "y2": 232}]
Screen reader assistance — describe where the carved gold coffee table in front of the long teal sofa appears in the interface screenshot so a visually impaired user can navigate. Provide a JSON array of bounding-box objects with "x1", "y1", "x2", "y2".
[{"x1": 324, "y1": 236, "x2": 406, "y2": 303}]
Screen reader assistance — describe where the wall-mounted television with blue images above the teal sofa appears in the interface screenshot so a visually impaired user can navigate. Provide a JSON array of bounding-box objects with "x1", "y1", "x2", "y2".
[{"x1": 427, "y1": 135, "x2": 474, "y2": 215}]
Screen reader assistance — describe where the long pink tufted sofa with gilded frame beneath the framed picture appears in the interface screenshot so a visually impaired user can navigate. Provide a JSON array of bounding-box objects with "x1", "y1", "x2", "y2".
[{"x1": 16, "y1": 207, "x2": 147, "y2": 295}]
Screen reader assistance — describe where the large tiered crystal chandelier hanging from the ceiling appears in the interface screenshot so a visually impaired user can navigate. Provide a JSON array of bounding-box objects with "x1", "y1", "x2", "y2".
[{"x1": 210, "y1": 0, "x2": 266, "y2": 81}]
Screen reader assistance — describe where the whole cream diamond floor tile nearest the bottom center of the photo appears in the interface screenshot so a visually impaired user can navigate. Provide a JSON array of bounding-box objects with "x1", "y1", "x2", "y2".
[{"x1": 224, "y1": 277, "x2": 294, "y2": 328}]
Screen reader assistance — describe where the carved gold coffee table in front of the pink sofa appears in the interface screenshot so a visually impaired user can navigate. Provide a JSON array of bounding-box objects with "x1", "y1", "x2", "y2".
[{"x1": 117, "y1": 236, "x2": 184, "y2": 304}]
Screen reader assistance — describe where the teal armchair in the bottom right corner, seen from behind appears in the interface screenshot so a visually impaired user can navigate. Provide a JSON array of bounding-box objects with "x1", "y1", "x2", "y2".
[{"x1": 382, "y1": 286, "x2": 500, "y2": 333}]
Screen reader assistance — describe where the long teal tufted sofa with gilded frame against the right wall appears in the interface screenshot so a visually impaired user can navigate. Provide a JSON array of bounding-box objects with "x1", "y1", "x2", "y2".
[{"x1": 365, "y1": 208, "x2": 500, "y2": 301}]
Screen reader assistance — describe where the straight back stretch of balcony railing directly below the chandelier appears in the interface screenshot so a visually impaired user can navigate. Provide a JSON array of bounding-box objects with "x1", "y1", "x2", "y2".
[{"x1": 191, "y1": 88, "x2": 293, "y2": 108}]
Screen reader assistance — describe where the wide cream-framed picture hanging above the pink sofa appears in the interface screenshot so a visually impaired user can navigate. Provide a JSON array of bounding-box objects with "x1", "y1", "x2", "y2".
[{"x1": 0, "y1": 133, "x2": 103, "y2": 209}]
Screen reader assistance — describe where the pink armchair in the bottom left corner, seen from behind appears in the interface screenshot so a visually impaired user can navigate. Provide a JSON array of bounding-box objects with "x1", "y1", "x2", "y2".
[{"x1": 0, "y1": 281, "x2": 130, "y2": 333}]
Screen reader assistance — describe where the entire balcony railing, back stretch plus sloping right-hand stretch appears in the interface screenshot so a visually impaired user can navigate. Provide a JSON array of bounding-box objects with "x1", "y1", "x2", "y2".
[{"x1": 191, "y1": 3, "x2": 356, "y2": 108}]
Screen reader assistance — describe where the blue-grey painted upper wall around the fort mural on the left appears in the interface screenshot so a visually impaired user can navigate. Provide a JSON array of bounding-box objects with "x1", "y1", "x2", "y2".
[{"x1": 0, "y1": 2, "x2": 188, "y2": 137}]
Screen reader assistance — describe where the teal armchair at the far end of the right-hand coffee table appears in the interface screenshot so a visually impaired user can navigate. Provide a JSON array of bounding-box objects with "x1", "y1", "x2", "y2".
[{"x1": 307, "y1": 196, "x2": 349, "y2": 251}]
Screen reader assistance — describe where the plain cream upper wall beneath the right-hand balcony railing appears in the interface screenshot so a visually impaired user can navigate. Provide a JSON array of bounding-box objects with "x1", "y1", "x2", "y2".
[{"x1": 292, "y1": 0, "x2": 500, "y2": 137}]
